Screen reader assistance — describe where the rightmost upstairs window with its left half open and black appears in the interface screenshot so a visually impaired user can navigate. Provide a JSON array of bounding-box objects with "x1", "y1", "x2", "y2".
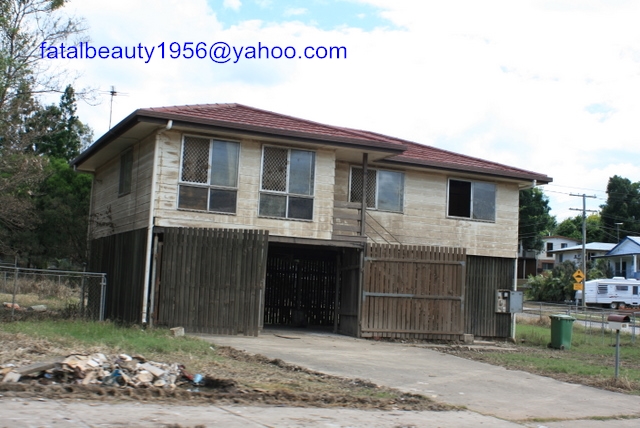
[{"x1": 447, "y1": 179, "x2": 496, "y2": 221}]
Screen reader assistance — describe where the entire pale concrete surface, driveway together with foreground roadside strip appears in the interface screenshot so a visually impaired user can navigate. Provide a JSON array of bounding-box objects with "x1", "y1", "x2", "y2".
[{"x1": 0, "y1": 330, "x2": 640, "y2": 428}]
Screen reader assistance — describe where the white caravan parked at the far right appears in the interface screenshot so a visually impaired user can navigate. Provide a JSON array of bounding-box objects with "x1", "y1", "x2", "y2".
[{"x1": 576, "y1": 277, "x2": 640, "y2": 309}]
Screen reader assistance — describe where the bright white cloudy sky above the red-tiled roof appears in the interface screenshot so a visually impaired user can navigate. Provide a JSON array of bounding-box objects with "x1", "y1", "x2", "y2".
[{"x1": 47, "y1": 0, "x2": 640, "y2": 221}]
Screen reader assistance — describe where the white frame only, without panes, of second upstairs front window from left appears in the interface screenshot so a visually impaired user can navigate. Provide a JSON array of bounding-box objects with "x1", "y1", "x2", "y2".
[{"x1": 258, "y1": 144, "x2": 318, "y2": 222}]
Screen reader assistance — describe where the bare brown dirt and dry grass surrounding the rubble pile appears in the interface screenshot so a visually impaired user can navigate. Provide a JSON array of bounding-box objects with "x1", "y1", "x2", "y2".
[{"x1": 0, "y1": 331, "x2": 452, "y2": 411}]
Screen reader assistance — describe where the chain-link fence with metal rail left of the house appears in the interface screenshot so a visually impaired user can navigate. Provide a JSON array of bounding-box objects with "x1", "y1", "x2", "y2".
[{"x1": 0, "y1": 265, "x2": 107, "y2": 321}]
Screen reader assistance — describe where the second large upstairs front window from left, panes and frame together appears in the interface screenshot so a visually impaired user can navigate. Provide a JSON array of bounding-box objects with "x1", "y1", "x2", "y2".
[{"x1": 259, "y1": 146, "x2": 316, "y2": 220}]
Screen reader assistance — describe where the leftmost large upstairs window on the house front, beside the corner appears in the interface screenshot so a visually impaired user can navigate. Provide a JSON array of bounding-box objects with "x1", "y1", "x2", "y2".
[{"x1": 178, "y1": 136, "x2": 240, "y2": 214}]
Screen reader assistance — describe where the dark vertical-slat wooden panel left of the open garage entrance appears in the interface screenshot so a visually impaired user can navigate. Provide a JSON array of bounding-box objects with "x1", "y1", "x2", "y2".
[{"x1": 157, "y1": 228, "x2": 268, "y2": 336}]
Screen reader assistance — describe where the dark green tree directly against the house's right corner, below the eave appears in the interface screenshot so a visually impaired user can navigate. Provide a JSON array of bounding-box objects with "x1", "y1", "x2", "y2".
[{"x1": 518, "y1": 187, "x2": 555, "y2": 251}]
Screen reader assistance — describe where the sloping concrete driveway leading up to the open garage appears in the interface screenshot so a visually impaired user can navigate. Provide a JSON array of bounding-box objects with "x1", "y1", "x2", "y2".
[{"x1": 199, "y1": 329, "x2": 640, "y2": 427}]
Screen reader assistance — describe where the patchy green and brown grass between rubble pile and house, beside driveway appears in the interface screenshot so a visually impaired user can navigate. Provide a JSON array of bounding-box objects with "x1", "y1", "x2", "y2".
[{"x1": 0, "y1": 320, "x2": 450, "y2": 410}]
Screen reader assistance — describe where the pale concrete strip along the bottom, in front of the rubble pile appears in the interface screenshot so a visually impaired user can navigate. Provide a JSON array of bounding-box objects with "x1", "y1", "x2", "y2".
[{"x1": 0, "y1": 397, "x2": 519, "y2": 428}]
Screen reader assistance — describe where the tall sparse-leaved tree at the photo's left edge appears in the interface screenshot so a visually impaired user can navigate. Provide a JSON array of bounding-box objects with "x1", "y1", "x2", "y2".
[{"x1": 0, "y1": 0, "x2": 84, "y2": 254}]
